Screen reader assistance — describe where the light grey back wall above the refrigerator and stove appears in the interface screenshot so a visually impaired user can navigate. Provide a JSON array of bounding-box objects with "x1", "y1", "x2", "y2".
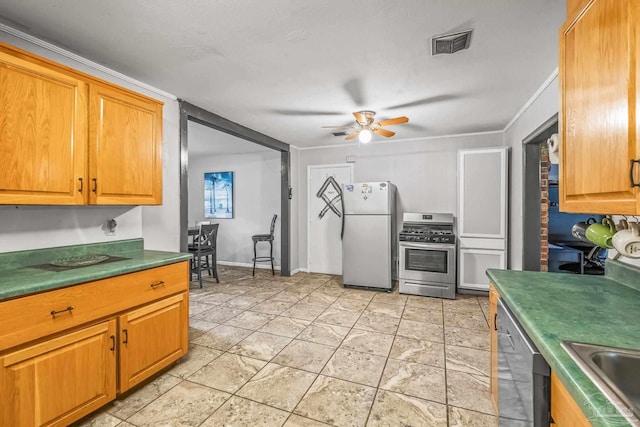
[{"x1": 292, "y1": 132, "x2": 503, "y2": 270}]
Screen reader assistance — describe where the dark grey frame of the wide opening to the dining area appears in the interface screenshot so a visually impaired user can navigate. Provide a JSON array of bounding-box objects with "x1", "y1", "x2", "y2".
[{"x1": 179, "y1": 100, "x2": 291, "y2": 276}]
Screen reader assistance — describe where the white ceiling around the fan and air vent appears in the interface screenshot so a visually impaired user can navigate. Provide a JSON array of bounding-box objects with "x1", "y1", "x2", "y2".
[{"x1": 0, "y1": 0, "x2": 565, "y2": 147}]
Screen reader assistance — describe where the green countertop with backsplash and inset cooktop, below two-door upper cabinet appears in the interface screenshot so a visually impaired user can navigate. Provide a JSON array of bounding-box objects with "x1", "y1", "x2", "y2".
[{"x1": 0, "y1": 239, "x2": 191, "y2": 301}]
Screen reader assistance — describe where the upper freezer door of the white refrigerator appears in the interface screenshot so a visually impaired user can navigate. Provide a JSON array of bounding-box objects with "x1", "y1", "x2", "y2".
[{"x1": 342, "y1": 181, "x2": 395, "y2": 215}]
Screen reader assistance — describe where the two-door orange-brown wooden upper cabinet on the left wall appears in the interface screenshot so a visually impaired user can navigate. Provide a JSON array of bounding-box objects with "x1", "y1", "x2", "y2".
[{"x1": 0, "y1": 43, "x2": 163, "y2": 205}]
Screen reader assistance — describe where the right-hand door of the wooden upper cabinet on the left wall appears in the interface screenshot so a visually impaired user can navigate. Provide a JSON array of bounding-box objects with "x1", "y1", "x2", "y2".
[{"x1": 89, "y1": 84, "x2": 162, "y2": 205}]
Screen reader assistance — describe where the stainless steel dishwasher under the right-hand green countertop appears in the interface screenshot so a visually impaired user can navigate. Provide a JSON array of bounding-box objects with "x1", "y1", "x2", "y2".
[{"x1": 497, "y1": 298, "x2": 551, "y2": 427}]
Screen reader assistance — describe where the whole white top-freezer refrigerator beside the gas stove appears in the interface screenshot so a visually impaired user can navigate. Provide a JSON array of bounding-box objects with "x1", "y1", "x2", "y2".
[{"x1": 342, "y1": 181, "x2": 398, "y2": 289}]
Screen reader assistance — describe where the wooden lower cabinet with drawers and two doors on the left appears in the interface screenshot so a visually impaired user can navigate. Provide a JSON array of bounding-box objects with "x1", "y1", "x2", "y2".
[{"x1": 0, "y1": 261, "x2": 189, "y2": 427}]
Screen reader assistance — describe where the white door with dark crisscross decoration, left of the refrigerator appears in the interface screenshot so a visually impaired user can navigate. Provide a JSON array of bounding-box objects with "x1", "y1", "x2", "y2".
[{"x1": 307, "y1": 163, "x2": 354, "y2": 275}]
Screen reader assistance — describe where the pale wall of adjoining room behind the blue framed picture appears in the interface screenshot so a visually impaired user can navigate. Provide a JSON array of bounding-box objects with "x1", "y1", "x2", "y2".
[{"x1": 188, "y1": 150, "x2": 281, "y2": 266}]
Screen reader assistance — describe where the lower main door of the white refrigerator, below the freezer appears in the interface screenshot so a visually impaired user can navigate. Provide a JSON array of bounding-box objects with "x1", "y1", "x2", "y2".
[{"x1": 342, "y1": 215, "x2": 393, "y2": 289}]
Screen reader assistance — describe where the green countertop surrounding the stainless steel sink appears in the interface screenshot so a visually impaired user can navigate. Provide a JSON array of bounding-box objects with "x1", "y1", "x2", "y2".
[{"x1": 487, "y1": 261, "x2": 640, "y2": 427}]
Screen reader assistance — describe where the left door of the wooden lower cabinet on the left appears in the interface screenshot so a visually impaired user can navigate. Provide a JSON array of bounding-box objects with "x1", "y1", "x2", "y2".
[{"x1": 0, "y1": 320, "x2": 116, "y2": 426}]
